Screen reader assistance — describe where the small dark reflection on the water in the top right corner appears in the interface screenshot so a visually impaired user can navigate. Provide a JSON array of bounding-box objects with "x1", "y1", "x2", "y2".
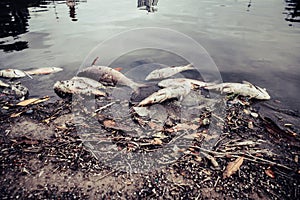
[{"x1": 285, "y1": 0, "x2": 300, "y2": 22}]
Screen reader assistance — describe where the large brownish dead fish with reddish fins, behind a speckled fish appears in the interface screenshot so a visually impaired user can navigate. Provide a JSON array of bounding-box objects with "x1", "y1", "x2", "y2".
[{"x1": 77, "y1": 65, "x2": 144, "y2": 91}]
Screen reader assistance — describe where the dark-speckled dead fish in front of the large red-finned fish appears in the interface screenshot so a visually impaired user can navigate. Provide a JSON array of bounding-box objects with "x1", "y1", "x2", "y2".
[{"x1": 53, "y1": 79, "x2": 106, "y2": 97}]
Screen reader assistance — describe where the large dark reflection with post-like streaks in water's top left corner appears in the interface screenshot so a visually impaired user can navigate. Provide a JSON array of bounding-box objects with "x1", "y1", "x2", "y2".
[{"x1": 0, "y1": 0, "x2": 87, "y2": 52}]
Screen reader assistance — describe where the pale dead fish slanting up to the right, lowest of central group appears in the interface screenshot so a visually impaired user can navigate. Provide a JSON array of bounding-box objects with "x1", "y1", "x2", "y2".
[{"x1": 137, "y1": 84, "x2": 191, "y2": 106}]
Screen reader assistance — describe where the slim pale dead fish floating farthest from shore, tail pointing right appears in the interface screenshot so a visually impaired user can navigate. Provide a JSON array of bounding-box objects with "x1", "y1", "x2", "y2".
[{"x1": 145, "y1": 64, "x2": 195, "y2": 81}]
